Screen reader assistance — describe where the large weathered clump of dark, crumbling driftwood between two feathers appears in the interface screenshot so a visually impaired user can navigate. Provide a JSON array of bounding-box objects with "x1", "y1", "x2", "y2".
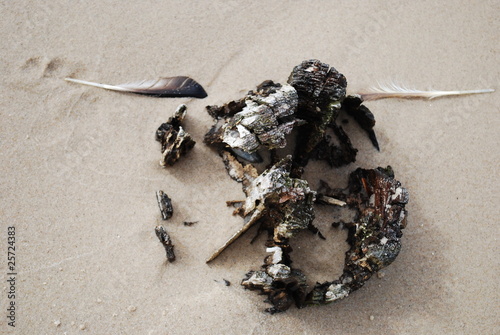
[{"x1": 197, "y1": 60, "x2": 408, "y2": 313}]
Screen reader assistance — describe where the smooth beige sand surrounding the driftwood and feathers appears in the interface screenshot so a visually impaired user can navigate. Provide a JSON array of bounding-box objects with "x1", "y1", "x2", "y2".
[{"x1": 0, "y1": 0, "x2": 500, "y2": 334}]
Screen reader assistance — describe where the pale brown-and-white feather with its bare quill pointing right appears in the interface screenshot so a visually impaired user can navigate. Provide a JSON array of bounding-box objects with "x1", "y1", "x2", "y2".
[{"x1": 358, "y1": 83, "x2": 495, "y2": 101}]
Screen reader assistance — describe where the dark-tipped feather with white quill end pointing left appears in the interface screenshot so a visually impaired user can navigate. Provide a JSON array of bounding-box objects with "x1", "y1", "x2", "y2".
[{"x1": 65, "y1": 76, "x2": 207, "y2": 98}]
